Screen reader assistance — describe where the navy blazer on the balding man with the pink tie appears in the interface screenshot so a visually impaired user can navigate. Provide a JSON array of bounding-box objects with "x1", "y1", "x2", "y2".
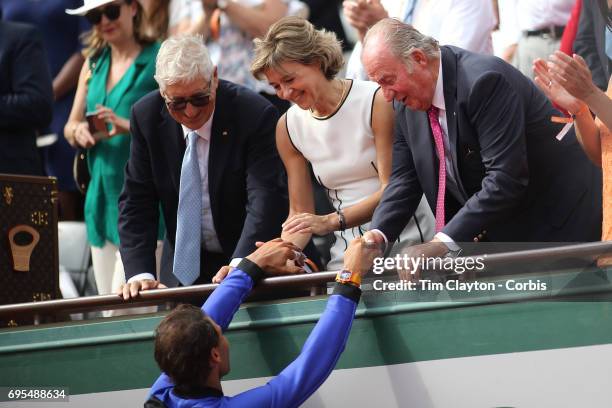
[{"x1": 372, "y1": 46, "x2": 602, "y2": 242}]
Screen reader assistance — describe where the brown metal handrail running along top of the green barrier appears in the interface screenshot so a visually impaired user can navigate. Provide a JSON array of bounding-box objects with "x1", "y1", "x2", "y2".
[{"x1": 0, "y1": 241, "x2": 612, "y2": 317}]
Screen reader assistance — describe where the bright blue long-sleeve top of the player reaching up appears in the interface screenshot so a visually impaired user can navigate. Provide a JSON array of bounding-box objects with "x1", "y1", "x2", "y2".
[{"x1": 149, "y1": 265, "x2": 359, "y2": 408}]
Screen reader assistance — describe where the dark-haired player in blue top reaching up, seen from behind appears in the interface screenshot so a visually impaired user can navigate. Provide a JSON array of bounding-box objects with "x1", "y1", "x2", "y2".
[{"x1": 145, "y1": 238, "x2": 367, "y2": 408}]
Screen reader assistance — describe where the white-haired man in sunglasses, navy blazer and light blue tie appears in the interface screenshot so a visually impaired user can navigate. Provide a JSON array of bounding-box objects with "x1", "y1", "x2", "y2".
[{"x1": 119, "y1": 36, "x2": 288, "y2": 299}]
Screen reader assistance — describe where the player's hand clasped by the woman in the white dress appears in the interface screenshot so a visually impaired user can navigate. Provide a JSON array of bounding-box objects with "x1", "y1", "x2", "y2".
[{"x1": 246, "y1": 238, "x2": 304, "y2": 275}]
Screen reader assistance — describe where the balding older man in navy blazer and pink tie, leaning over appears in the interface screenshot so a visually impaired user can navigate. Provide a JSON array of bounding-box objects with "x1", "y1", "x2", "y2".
[{"x1": 362, "y1": 19, "x2": 601, "y2": 262}]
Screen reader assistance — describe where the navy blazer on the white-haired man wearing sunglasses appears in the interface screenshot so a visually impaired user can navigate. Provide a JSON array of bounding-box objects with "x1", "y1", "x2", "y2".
[{"x1": 119, "y1": 80, "x2": 289, "y2": 279}]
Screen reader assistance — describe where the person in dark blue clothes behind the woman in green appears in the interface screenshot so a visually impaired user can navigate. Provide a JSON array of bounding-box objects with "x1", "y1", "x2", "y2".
[{"x1": 0, "y1": 0, "x2": 89, "y2": 220}]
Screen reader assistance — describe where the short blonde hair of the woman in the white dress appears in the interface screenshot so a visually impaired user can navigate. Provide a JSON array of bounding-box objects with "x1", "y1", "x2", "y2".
[{"x1": 251, "y1": 17, "x2": 344, "y2": 80}]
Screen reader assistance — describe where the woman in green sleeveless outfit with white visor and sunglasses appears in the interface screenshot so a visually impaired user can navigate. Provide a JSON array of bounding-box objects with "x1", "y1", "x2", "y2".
[{"x1": 64, "y1": 0, "x2": 163, "y2": 300}]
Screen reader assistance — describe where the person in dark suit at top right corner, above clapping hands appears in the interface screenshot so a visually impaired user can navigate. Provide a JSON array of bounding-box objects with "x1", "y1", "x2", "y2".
[{"x1": 574, "y1": 0, "x2": 612, "y2": 90}]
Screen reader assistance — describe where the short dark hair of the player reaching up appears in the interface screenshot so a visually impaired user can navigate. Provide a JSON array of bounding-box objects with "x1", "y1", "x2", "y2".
[{"x1": 155, "y1": 305, "x2": 219, "y2": 392}]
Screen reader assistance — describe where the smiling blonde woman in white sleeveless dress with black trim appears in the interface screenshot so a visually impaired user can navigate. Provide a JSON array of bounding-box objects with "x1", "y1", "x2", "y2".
[{"x1": 251, "y1": 17, "x2": 433, "y2": 270}]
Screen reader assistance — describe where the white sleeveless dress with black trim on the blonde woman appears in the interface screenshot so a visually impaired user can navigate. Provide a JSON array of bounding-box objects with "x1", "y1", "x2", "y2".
[{"x1": 287, "y1": 80, "x2": 434, "y2": 271}]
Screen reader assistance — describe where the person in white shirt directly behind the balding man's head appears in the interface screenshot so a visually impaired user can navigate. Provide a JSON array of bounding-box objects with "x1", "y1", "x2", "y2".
[{"x1": 343, "y1": 0, "x2": 497, "y2": 79}]
